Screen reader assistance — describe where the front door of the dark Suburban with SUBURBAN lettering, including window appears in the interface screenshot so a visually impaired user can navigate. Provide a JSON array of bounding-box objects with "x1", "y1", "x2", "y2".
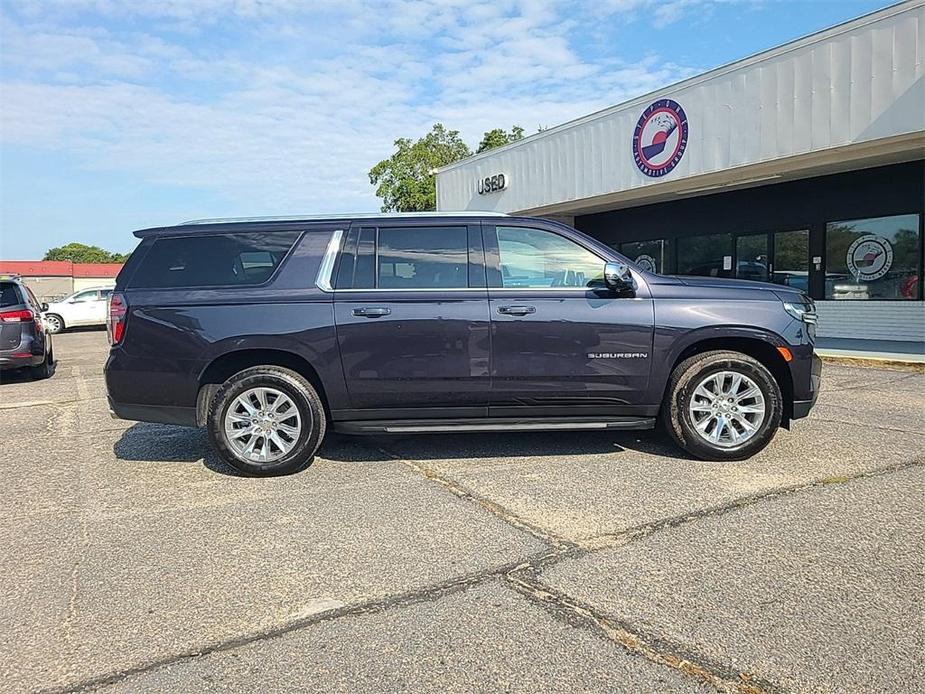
[{"x1": 483, "y1": 222, "x2": 654, "y2": 417}]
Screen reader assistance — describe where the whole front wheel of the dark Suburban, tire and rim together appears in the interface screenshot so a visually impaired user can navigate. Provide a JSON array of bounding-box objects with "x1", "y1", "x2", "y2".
[{"x1": 662, "y1": 351, "x2": 784, "y2": 460}]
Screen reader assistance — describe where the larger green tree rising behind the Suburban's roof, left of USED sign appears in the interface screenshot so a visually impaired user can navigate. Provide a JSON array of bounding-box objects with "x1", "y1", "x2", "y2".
[{"x1": 369, "y1": 123, "x2": 472, "y2": 212}]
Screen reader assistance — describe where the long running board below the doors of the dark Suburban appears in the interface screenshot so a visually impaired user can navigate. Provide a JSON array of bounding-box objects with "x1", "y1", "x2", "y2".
[{"x1": 333, "y1": 417, "x2": 655, "y2": 434}]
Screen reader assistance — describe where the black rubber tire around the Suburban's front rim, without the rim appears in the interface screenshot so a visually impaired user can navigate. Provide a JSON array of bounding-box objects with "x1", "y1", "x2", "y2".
[{"x1": 661, "y1": 351, "x2": 784, "y2": 461}]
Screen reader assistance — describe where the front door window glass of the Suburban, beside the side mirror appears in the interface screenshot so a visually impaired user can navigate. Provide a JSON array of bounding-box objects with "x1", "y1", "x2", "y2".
[{"x1": 497, "y1": 226, "x2": 604, "y2": 289}]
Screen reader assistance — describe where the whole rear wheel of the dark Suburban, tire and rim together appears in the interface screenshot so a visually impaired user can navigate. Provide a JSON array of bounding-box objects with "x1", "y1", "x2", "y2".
[{"x1": 208, "y1": 366, "x2": 325, "y2": 476}]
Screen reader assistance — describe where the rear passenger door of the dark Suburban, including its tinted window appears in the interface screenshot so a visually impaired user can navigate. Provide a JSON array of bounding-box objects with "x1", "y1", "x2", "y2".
[{"x1": 334, "y1": 226, "x2": 491, "y2": 419}]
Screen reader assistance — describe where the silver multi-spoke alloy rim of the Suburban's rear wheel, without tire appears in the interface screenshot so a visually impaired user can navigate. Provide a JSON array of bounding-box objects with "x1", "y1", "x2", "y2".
[{"x1": 225, "y1": 388, "x2": 302, "y2": 463}]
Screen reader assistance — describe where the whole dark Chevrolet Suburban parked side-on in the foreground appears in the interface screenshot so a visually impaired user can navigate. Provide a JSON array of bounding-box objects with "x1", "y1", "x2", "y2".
[{"x1": 106, "y1": 213, "x2": 821, "y2": 475}]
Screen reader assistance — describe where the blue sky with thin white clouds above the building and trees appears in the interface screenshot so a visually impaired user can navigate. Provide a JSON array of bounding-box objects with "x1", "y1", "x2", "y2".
[{"x1": 0, "y1": 0, "x2": 890, "y2": 260}]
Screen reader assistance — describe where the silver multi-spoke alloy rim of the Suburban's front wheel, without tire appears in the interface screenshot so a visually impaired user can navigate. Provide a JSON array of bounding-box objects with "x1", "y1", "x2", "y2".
[{"x1": 688, "y1": 371, "x2": 765, "y2": 448}]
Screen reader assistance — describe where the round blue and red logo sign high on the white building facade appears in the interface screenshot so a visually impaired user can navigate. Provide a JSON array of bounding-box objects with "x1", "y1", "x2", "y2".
[{"x1": 633, "y1": 99, "x2": 687, "y2": 178}]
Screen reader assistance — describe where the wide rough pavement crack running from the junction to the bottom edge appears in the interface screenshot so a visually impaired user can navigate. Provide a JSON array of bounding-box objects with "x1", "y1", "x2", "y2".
[{"x1": 504, "y1": 566, "x2": 780, "y2": 694}]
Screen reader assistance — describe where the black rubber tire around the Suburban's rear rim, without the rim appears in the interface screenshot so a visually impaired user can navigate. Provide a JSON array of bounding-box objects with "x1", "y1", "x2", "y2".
[{"x1": 207, "y1": 366, "x2": 326, "y2": 477}]
